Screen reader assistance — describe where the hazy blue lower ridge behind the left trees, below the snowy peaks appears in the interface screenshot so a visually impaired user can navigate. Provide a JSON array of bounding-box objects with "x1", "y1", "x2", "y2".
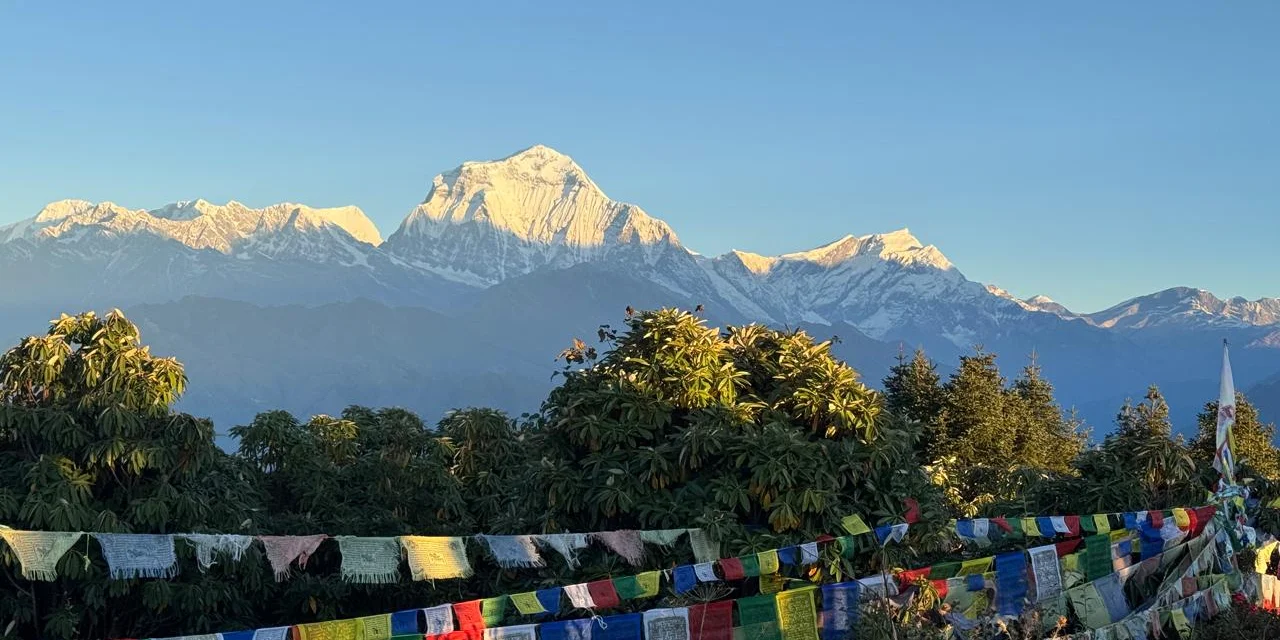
[{"x1": 125, "y1": 297, "x2": 550, "y2": 431}]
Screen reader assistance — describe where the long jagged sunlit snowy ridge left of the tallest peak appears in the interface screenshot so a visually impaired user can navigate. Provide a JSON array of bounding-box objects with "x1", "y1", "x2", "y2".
[{"x1": 0, "y1": 200, "x2": 458, "y2": 308}]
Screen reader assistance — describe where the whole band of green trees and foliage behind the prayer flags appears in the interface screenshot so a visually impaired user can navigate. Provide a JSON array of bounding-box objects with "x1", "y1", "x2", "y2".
[{"x1": 0, "y1": 310, "x2": 1280, "y2": 639}]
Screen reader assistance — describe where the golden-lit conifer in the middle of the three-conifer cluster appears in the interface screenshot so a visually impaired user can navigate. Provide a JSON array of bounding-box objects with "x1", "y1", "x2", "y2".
[{"x1": 940, "y1": 348, "x2": 1016, "y2": 465}]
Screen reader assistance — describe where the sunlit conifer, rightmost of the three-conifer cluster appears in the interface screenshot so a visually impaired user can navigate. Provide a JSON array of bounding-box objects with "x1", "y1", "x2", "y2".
[{"x1": 1006, "y1": 353, "x2": 1085, "y2": 471}]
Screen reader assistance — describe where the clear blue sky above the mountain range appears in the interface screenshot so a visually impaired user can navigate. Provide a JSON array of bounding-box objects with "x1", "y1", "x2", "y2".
[{"x1": 0, "y1": 0, "x2": 1280, "y2": 311}]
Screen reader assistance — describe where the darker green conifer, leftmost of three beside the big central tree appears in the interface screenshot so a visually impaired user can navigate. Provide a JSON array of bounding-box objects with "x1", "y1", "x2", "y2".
[{"x1": 884, "y1": 349, "x2": 943, "y2": 461}]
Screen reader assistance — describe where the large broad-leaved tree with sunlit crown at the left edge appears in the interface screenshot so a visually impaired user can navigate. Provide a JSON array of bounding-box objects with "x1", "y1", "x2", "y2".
[{"x1": 0, "y1": 311, "x2": 261, "y2": 637}]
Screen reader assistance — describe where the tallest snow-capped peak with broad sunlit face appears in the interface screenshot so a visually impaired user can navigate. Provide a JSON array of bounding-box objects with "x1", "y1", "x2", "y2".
[{"x1": 384, "y1": 146, "x2": 687, "y2": 287}]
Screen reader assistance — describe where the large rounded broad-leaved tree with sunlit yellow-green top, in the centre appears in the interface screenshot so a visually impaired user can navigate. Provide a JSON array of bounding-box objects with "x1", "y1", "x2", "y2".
[{"x1": 524, "y1": 310, "x2": 943, "y2": 565}]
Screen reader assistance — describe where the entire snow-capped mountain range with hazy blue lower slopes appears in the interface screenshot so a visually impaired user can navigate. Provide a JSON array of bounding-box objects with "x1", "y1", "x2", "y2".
[{"x1": 0, "y1": 146, "x2": 1280, "y2": 433}]
